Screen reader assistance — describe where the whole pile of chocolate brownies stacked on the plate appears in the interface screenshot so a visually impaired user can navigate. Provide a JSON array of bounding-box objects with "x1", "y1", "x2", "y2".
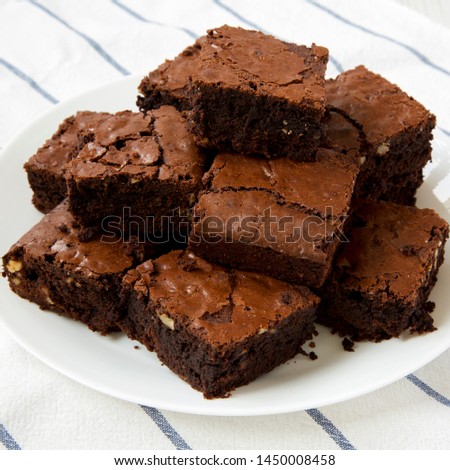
[{"x1": 3, "y1": 26, "x2": 448, "y2": 398}]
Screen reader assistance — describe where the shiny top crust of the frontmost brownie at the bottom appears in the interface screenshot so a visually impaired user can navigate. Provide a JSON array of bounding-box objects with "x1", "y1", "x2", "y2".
[{"x1": 124, "y1": 250, "x2": 319, "y2": 347}]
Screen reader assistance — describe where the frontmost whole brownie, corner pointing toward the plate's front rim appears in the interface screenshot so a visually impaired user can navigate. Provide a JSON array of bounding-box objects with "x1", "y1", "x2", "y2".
[{"x1": 121, "y1": 251, "x2": 319, "y2": 398}]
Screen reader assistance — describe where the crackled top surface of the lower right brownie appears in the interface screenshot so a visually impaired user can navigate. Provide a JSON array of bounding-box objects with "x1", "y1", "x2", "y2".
[{"x1": 336, "y1": 200, "x2": 448, "y2": 297}]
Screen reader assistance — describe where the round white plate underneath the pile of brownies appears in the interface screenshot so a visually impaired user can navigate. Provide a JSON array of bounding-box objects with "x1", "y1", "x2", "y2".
[{"x1": 0, "y1": 77, "x2": 450, "y2": 416}]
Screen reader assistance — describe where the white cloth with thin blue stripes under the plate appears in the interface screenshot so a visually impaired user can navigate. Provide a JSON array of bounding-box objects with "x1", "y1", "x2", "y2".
[{"x1": 0, "y1": 0, "x2": 450, "y2": 449}]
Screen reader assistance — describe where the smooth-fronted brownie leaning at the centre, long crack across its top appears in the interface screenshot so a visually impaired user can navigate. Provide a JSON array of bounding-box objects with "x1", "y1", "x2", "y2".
[{"x1": 189, "y1": 149, "x2": 357, "y2": 287}]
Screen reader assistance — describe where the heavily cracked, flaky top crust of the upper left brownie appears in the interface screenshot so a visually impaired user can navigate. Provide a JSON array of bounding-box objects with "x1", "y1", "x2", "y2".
[{"x1": 68, "y1": 106, "x2": 204, "y2": 183}]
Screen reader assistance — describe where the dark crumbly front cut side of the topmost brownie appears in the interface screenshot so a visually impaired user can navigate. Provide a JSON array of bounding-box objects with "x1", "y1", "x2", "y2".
[{"x1": 188, "y1": 83, "x2": 325, "y2": 161}]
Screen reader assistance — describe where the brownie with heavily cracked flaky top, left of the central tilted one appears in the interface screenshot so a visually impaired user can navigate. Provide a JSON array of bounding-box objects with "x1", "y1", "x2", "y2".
[{"x1": 66, "y1": 106, "x2": 206, "y2": 236}]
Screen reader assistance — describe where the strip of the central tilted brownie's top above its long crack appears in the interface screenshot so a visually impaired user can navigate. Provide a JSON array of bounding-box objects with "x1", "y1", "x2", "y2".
[{"x1": 204, "y1": 149, "x2": 358, "y2": 219}]
